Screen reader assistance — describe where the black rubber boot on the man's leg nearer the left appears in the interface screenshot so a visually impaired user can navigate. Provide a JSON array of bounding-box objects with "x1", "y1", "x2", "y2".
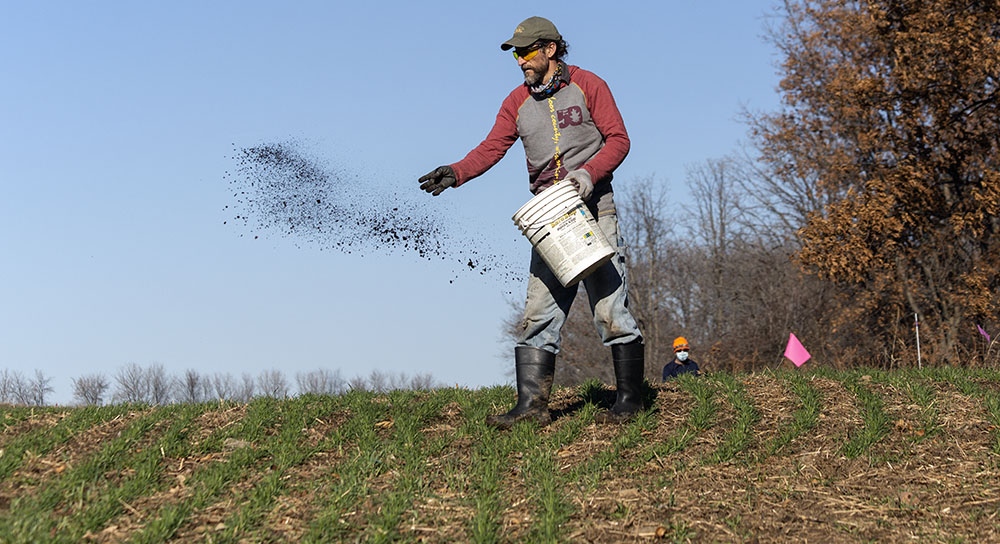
[{"x1": 486, "y1": 346, "x2": 556, "y2": 429}]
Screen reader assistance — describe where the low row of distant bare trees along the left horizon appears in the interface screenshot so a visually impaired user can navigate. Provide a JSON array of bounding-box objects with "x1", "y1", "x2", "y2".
[{"x1": 0, "y1": 363, "x2": 440, "y2": 406}]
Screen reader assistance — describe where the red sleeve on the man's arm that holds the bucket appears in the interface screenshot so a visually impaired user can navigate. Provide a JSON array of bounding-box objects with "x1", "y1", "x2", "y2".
[{"x1": 574, "y1": 72, "x2": 632, "y2": 183}]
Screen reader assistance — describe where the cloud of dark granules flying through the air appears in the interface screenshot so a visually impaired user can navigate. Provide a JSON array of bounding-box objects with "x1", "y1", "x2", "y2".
[{"x1": 223, "y1": 140, "x2": 521, "y2": 283}]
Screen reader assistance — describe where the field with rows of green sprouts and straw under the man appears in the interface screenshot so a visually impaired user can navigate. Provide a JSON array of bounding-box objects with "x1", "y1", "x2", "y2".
[{"x1": 0, "y1": 369, "x2": 1000, "y2": 542}]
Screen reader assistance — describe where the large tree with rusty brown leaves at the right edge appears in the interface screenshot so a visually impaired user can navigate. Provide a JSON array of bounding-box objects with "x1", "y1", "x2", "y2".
[{"x1": 752, "y1": 0, "x2": 1000, "y2": 362}]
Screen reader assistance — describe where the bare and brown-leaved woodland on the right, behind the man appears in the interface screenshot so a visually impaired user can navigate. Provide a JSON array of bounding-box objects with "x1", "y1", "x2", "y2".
[{"x1": 507, "y1": 0, "x2": 1000, "y2": 384}]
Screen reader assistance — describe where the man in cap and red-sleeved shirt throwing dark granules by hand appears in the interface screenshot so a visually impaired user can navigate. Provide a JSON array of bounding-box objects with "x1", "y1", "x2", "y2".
[{"x1": 420, "y1": 17, "x2": 644, "y2": 429}]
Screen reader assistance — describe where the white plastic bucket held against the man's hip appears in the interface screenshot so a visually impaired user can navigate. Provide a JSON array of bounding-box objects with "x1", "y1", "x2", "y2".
[{"x1": 513, "y1": 183, "x2": 615, "y2": 287}]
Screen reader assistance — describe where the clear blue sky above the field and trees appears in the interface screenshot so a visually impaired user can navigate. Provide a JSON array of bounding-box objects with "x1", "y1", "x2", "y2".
[{"x1": 0, "y1": 1, "x2": 778, "y2": 403}]
